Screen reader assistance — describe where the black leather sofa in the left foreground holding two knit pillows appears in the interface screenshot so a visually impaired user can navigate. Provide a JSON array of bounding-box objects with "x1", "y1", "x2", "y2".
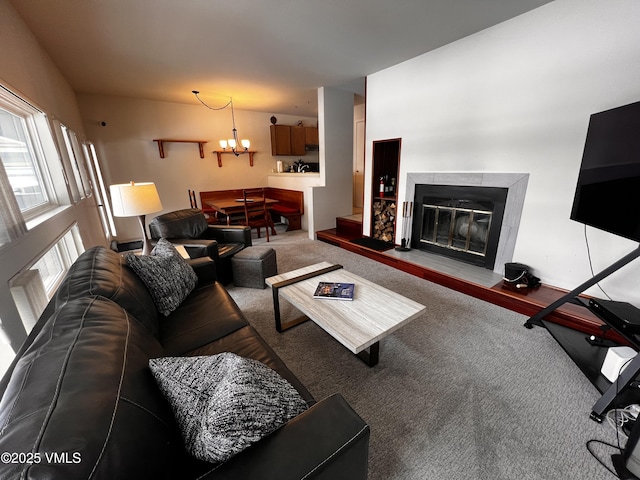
[{"x1": 0, "y1": 247, "x2": 369, "y2": 480}]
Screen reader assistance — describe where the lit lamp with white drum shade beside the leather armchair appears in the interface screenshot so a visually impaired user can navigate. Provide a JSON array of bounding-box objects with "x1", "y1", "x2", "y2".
[{"x1": 109, "y1": 182, "x2": 162, "y2": 255}]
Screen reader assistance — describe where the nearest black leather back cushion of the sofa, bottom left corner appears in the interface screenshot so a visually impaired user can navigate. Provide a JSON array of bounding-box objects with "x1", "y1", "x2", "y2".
[{"x1": 0, "y1": 296, "x2": 184, "y2": 479}]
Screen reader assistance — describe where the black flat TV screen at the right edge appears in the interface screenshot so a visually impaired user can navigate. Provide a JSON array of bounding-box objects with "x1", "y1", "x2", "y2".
[{"x1": 571, "y1": 102, "x2": 640, "y2": 242}]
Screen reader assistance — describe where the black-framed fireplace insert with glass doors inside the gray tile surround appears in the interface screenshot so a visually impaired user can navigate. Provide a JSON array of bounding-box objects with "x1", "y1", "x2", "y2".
[{"x1": 411, "y1": 184, "x2": 508, "y2": 270}]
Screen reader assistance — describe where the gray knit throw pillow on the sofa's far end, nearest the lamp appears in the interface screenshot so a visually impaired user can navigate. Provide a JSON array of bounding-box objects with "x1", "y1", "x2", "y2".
[{"x1": 126, "y1": 238, "x2": 198, "y2": 316}]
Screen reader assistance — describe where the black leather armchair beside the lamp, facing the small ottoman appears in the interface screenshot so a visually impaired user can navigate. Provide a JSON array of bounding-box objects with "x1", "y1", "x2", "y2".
[{"x1": 149, "y1": 208, "x2": 251, "y2": 285}]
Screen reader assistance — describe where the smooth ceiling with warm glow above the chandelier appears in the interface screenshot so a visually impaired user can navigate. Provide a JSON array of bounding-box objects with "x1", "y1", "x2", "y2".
[{"x1": 9, "y1": 0, "x2": 549, "y2": 116}]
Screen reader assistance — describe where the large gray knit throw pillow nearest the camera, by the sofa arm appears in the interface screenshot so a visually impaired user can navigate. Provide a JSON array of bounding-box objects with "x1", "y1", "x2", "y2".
[{"x1": 149, "y1": 352, "x2": 307, "y2": 463}]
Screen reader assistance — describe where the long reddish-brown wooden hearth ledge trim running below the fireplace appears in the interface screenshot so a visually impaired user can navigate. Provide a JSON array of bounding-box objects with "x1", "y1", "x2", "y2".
[{"x1": 316, "y1": 228, "x2": 626, "y2": 343}]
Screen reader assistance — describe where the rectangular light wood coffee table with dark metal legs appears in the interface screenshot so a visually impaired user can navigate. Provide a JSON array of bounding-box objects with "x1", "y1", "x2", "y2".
[{"x1": 265, "y1": 262, "x2": 426, "y2": 366}]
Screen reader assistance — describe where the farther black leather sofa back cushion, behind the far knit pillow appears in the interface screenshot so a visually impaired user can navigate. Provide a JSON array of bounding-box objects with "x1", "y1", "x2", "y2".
[{"x1": 54, "y1": 246, "x2": 158, "y2": 337}]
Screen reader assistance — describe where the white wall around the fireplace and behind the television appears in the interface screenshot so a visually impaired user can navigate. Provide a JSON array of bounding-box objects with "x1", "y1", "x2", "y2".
[{"x1": 364, "y1": 0, "x2": 640, "y2": 305}]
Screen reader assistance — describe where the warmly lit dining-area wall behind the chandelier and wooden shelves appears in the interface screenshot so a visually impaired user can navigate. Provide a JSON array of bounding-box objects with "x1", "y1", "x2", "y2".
[{"x1": 78, "y1": 94, "x2": 318, "y2": 240}]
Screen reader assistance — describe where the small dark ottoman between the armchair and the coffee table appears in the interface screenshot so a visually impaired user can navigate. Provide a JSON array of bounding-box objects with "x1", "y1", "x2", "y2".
[{"x1": 231, "y1": 247, "x2": 278, "y2": 288}]
